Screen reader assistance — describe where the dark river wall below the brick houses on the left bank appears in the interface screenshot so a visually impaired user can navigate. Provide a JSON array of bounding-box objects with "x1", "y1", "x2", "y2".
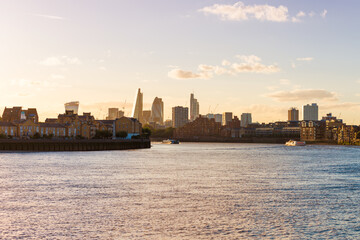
[{"x1": 0, "y1": 139, "x2": 151, "y2": 152}]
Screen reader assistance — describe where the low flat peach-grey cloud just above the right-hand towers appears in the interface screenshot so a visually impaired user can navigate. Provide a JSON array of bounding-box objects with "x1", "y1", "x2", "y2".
[{"x1": 267, "y1": 89, "x2": 338, "y2": 102}]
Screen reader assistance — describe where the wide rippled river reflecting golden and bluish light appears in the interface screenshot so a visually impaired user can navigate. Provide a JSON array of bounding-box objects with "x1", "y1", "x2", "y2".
[{"x1": 0, "y1": 143, "x2": 360, "y2": 239}]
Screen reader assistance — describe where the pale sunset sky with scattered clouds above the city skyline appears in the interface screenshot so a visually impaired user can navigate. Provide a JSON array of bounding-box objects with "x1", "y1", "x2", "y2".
[{"x1": 0, "y1": 0, "x2": 360, "y2": 125}]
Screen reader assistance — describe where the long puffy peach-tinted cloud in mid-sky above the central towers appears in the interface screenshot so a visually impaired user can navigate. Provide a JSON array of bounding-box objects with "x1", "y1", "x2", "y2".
[{"x1": 168, "y1": 55, "x2": 280, "y2": 79}]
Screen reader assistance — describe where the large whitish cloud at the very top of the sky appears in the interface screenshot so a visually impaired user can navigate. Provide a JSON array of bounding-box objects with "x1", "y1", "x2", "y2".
[{"x1": 199, "y1": 2, "x2": 289, "y2": 22}]
